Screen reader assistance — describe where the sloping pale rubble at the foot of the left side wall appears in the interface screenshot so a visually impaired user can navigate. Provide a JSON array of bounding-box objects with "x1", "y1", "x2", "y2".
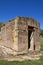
[{"x1": 0, "y1": 45, "x2": 17, "y2": 56}]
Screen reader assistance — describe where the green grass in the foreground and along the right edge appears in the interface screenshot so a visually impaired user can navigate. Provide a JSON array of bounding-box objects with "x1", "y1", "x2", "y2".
[{"x1": 0, "y1": 38, "x2": 43, "y2": 65}]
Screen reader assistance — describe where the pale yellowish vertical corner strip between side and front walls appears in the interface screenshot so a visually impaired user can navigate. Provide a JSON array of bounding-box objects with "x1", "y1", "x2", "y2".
[{"x1": 13, "y1": 19, "x2": 18, "y2": 51}]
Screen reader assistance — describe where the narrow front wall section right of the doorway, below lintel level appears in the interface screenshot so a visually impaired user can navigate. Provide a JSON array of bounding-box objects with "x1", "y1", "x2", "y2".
[{"x1": 34, "y1": 25, "x2": 40, "y2": 51}]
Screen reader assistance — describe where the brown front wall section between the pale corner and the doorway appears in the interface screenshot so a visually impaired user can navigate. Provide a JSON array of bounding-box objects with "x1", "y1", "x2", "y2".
[{"x1": 18, "y1": 18, "x2": 28, "y2": 52}]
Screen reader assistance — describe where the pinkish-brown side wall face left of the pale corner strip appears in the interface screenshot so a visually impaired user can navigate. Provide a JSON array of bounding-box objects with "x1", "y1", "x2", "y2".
[{"x1": 1, "y1": 23, "x2": 13, "y2": 48}]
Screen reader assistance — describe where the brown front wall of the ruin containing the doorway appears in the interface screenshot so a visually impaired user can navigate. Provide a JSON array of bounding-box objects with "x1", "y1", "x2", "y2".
[{"x1": 18, "y1": 17, "x2": 40, "y2": 51}]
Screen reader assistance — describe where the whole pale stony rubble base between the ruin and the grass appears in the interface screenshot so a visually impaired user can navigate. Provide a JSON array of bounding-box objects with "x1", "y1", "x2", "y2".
[{"x1": 0, "y1": 46, "x2": 41, "y2": 61}]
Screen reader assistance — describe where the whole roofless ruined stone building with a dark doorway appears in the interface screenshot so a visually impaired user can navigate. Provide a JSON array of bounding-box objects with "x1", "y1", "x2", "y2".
[{"x1": 0, "y1": 17, "x2": 40, "y2": 54}]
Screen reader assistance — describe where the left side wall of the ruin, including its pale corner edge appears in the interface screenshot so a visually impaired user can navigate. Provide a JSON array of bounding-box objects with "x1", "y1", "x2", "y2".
[{"x1": 1, "y1": 19, "x2": 18, "y2": 51}]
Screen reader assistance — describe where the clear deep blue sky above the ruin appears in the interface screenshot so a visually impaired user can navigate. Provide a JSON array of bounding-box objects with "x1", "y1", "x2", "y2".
[{"x1": 0, "y1": 0, "x2": 43, "y2": 29}]
